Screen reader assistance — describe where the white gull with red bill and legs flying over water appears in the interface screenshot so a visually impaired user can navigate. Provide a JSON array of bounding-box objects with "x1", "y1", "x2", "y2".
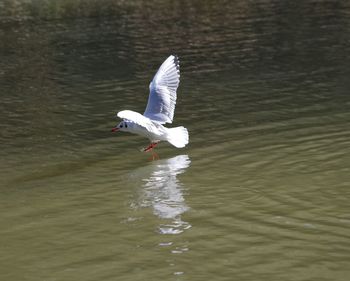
[{"x1": 112, "y1": 55, "x2": 188, "y2": 151}]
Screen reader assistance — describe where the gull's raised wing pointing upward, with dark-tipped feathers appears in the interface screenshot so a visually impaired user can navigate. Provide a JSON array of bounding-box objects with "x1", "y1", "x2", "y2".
[{"x1": 143, "y1": 55, "x2": 180, "y2": 124}]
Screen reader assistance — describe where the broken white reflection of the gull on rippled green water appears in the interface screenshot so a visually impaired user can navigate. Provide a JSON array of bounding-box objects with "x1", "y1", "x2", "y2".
[{"x1": 134, "y1": 155, "x2": 191, "y2": 234}]
